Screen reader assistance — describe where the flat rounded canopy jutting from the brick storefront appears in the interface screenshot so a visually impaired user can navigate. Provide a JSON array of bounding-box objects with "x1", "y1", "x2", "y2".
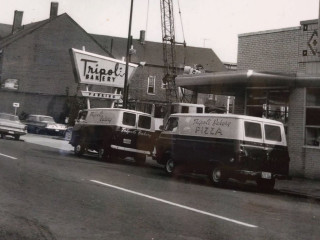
[{"x1": 176, "y1": 70, "x2": 320, "y2": 95}]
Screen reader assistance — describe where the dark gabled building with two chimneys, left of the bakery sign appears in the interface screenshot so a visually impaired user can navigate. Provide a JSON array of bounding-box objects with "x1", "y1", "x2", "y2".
[{"x1": 0, "y1": 4, "x2": 111, "y2": 120}]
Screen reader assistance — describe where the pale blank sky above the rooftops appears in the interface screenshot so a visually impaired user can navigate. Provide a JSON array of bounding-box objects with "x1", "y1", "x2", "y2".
[{"x1": 0, "y1": 0, "x2": 320, "y2": 63}]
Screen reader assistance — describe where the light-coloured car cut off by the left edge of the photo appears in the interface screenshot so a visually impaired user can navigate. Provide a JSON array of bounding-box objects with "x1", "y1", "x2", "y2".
[{"x1": 0, "y1": 113, "x2": 27, "y2": 140}]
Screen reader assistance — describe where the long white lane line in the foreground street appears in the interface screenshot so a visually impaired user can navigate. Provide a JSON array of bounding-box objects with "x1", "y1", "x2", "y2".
[{"x1": 90, "y1": 180, "x2": 258, "y2": 228}]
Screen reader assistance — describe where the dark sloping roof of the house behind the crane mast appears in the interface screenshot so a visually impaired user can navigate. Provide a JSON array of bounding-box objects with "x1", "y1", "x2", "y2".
[{"x1": 92, "y1": 34, "x2": 226, "y2": 72}]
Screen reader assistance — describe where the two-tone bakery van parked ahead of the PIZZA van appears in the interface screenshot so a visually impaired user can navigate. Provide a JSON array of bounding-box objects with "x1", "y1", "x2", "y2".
[{"x1": 70, "y1": 108, "x2": 155, "y2": 164}]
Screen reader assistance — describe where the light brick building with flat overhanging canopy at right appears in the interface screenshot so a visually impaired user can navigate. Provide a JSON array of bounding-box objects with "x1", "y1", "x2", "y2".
[{"x1": 177, "y1": 20, "x2": 320, "y2": 179}]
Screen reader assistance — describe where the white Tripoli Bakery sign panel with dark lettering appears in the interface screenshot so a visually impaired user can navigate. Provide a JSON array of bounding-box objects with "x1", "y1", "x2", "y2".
[{"x1": 70, "y1": 48, "x2": 138, "y2": 88}]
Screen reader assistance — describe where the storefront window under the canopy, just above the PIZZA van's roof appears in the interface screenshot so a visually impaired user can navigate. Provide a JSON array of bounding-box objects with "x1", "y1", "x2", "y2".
[{"x1": 246, "y1": 88, "x2": 289, "y2": 124}]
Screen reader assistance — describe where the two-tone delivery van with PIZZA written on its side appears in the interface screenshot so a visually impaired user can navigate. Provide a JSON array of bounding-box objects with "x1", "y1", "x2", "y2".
[{"x1": 154, "y1": 114, "x2": 290, "y2": 190}]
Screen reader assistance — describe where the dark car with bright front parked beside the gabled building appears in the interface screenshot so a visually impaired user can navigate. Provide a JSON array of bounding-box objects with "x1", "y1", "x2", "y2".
[{"x1": 25, "y1": 115, "x2": 67, "y2": 135}]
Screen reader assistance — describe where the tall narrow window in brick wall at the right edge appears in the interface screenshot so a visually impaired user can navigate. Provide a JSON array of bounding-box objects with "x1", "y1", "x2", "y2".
[{"x1": 305, "y1": 88, "x2": 320, "y2": 147}]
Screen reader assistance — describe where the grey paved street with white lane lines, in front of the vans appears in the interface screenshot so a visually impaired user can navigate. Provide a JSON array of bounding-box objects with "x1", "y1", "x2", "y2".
[{"x1": 0, "y1": 134, "x2": 320, "y2": 240}]
